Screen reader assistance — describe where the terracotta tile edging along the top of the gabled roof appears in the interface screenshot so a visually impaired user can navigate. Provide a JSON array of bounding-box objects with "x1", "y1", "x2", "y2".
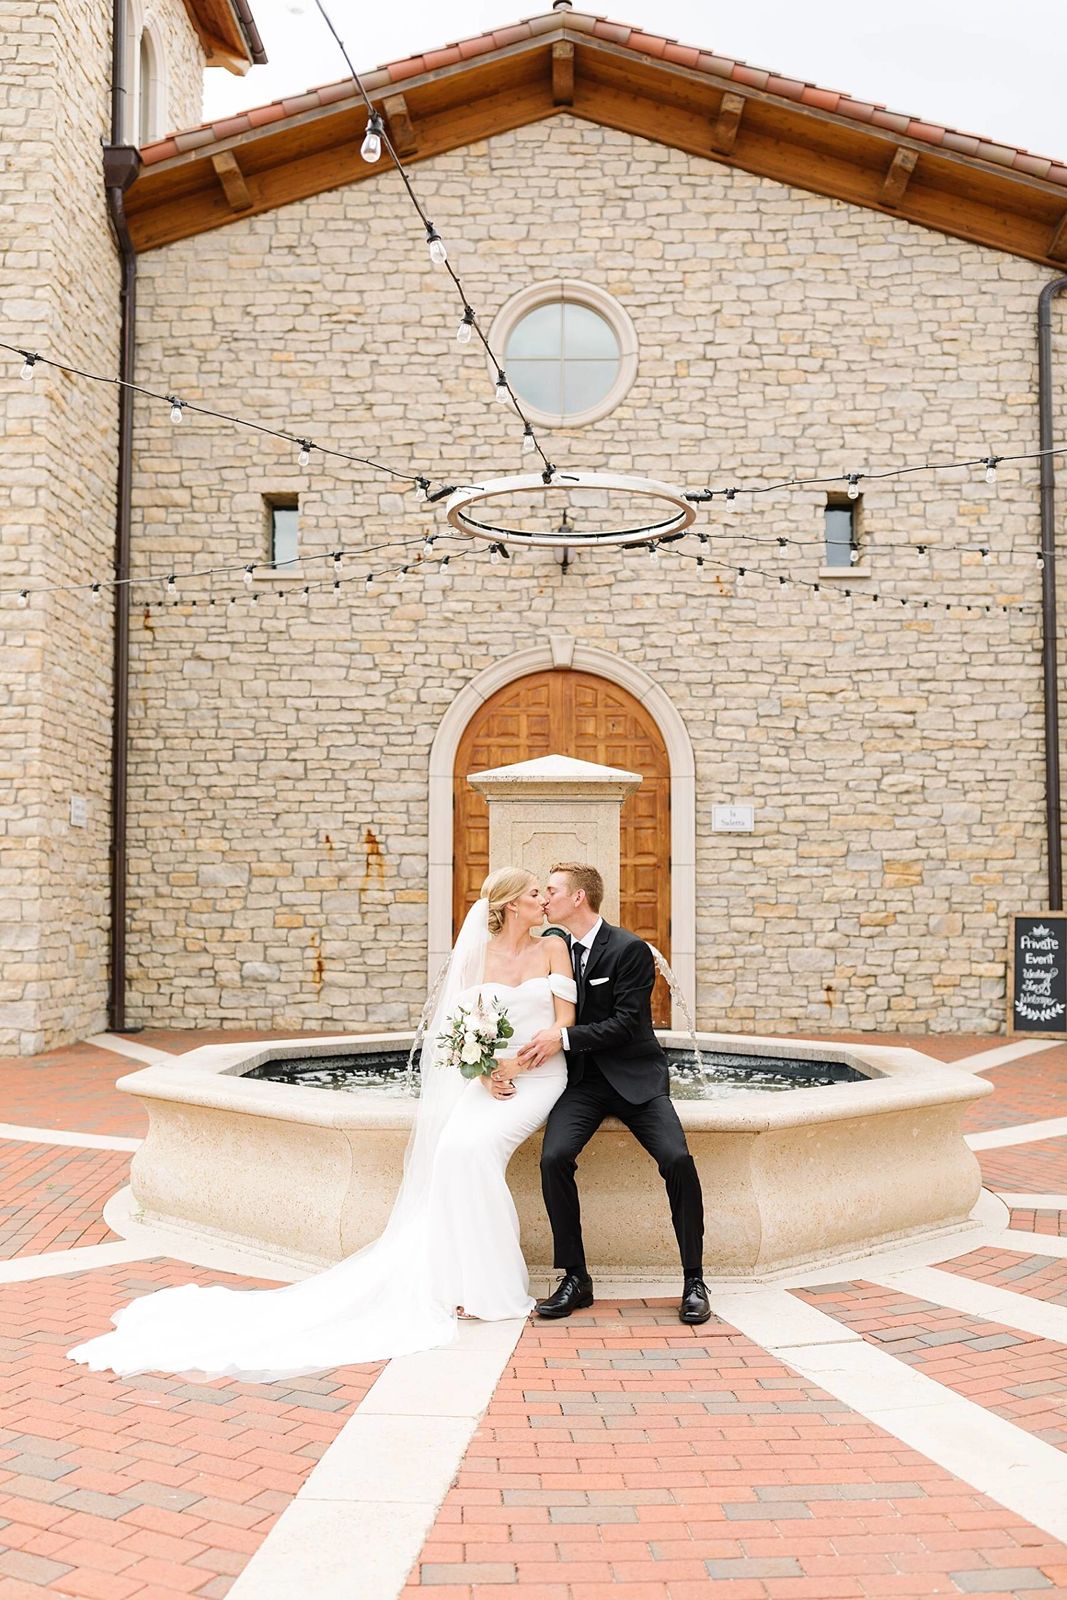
[{"x1": 141, "y1": 11, "x2": 1067, "y2": 198}]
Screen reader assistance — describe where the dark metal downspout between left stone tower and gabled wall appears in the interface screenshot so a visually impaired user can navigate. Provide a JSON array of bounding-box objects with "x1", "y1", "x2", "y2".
[{"x1": 104, "y1": 0, "x2": 141, "y2": 1034}]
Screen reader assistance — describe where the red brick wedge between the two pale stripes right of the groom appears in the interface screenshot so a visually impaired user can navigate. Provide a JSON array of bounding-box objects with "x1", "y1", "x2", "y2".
[{"x1": 793, "y1": 1282, "x2": 1067, "y2": 1450}]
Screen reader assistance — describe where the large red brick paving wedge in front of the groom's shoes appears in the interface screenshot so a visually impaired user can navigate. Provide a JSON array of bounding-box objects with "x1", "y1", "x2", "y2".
[{"x1": 403, "y1": 1302, "x2": 1067, "y2": 1600}]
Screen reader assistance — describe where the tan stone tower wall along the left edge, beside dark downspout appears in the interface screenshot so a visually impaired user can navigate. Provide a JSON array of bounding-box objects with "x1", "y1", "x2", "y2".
[{"x1": 0, "y1": 0, "x2": 206, "y2": 1054}]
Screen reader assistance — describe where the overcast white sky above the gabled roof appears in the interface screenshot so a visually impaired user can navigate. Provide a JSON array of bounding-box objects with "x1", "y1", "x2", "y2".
[{"x1": 205, "y1": 0, "x2": 1067, "y2": 158}]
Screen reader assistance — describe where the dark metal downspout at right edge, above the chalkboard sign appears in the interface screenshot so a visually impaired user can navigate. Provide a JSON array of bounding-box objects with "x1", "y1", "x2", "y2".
[{"x1": 1037, "y1": 277, "x2": 1067, "y2": 910}]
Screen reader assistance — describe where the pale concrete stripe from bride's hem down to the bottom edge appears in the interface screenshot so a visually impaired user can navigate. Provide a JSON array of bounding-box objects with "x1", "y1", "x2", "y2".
[{"x1": 227, "y1": 1320, "x2": 526, "y2": 1600}]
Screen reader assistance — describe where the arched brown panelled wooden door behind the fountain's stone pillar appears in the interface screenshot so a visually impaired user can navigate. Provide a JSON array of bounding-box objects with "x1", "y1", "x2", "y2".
[{"x1": 453, "y1": 670, "x2": 670, "y2": 1027}]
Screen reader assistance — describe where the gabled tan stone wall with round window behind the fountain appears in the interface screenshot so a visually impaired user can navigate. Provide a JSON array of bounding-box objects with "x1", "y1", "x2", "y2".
[{"x1": 6, "y1": 12, "x2": 1067, "y2": 1048}]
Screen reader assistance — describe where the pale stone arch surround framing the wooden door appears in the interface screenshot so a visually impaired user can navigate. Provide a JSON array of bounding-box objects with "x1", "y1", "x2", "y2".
[{"x1": 427, "y1": 638, "x2": 696, "y2": 1027}]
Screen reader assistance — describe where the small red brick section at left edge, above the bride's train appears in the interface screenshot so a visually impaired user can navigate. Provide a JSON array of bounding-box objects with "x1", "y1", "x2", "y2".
[{"x1": 0, "y1": 1139, "x2": 130, "y2": 1261}]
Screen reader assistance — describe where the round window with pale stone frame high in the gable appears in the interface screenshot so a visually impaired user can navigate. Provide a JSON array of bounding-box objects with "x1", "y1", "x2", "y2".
[{"x1": 493, "y1": 283, "x2": 637, "y2": 426}]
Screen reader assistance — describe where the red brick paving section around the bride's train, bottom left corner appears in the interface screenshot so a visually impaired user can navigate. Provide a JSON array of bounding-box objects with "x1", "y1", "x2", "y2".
[{"x1": 0, "y1": 1261, "x2": 381, "y2": 1600}]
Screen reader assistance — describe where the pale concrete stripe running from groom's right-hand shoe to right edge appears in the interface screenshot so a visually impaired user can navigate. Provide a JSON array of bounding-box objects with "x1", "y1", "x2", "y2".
[{"x1": 712, "y1": 1290, "x2": 1067, "y2": 1539}]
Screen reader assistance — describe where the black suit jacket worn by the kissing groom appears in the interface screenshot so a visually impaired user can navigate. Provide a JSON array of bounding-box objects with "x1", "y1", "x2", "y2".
[{"x1": 566, "y1": 922, "x2": 669, "y2": 1106}]
